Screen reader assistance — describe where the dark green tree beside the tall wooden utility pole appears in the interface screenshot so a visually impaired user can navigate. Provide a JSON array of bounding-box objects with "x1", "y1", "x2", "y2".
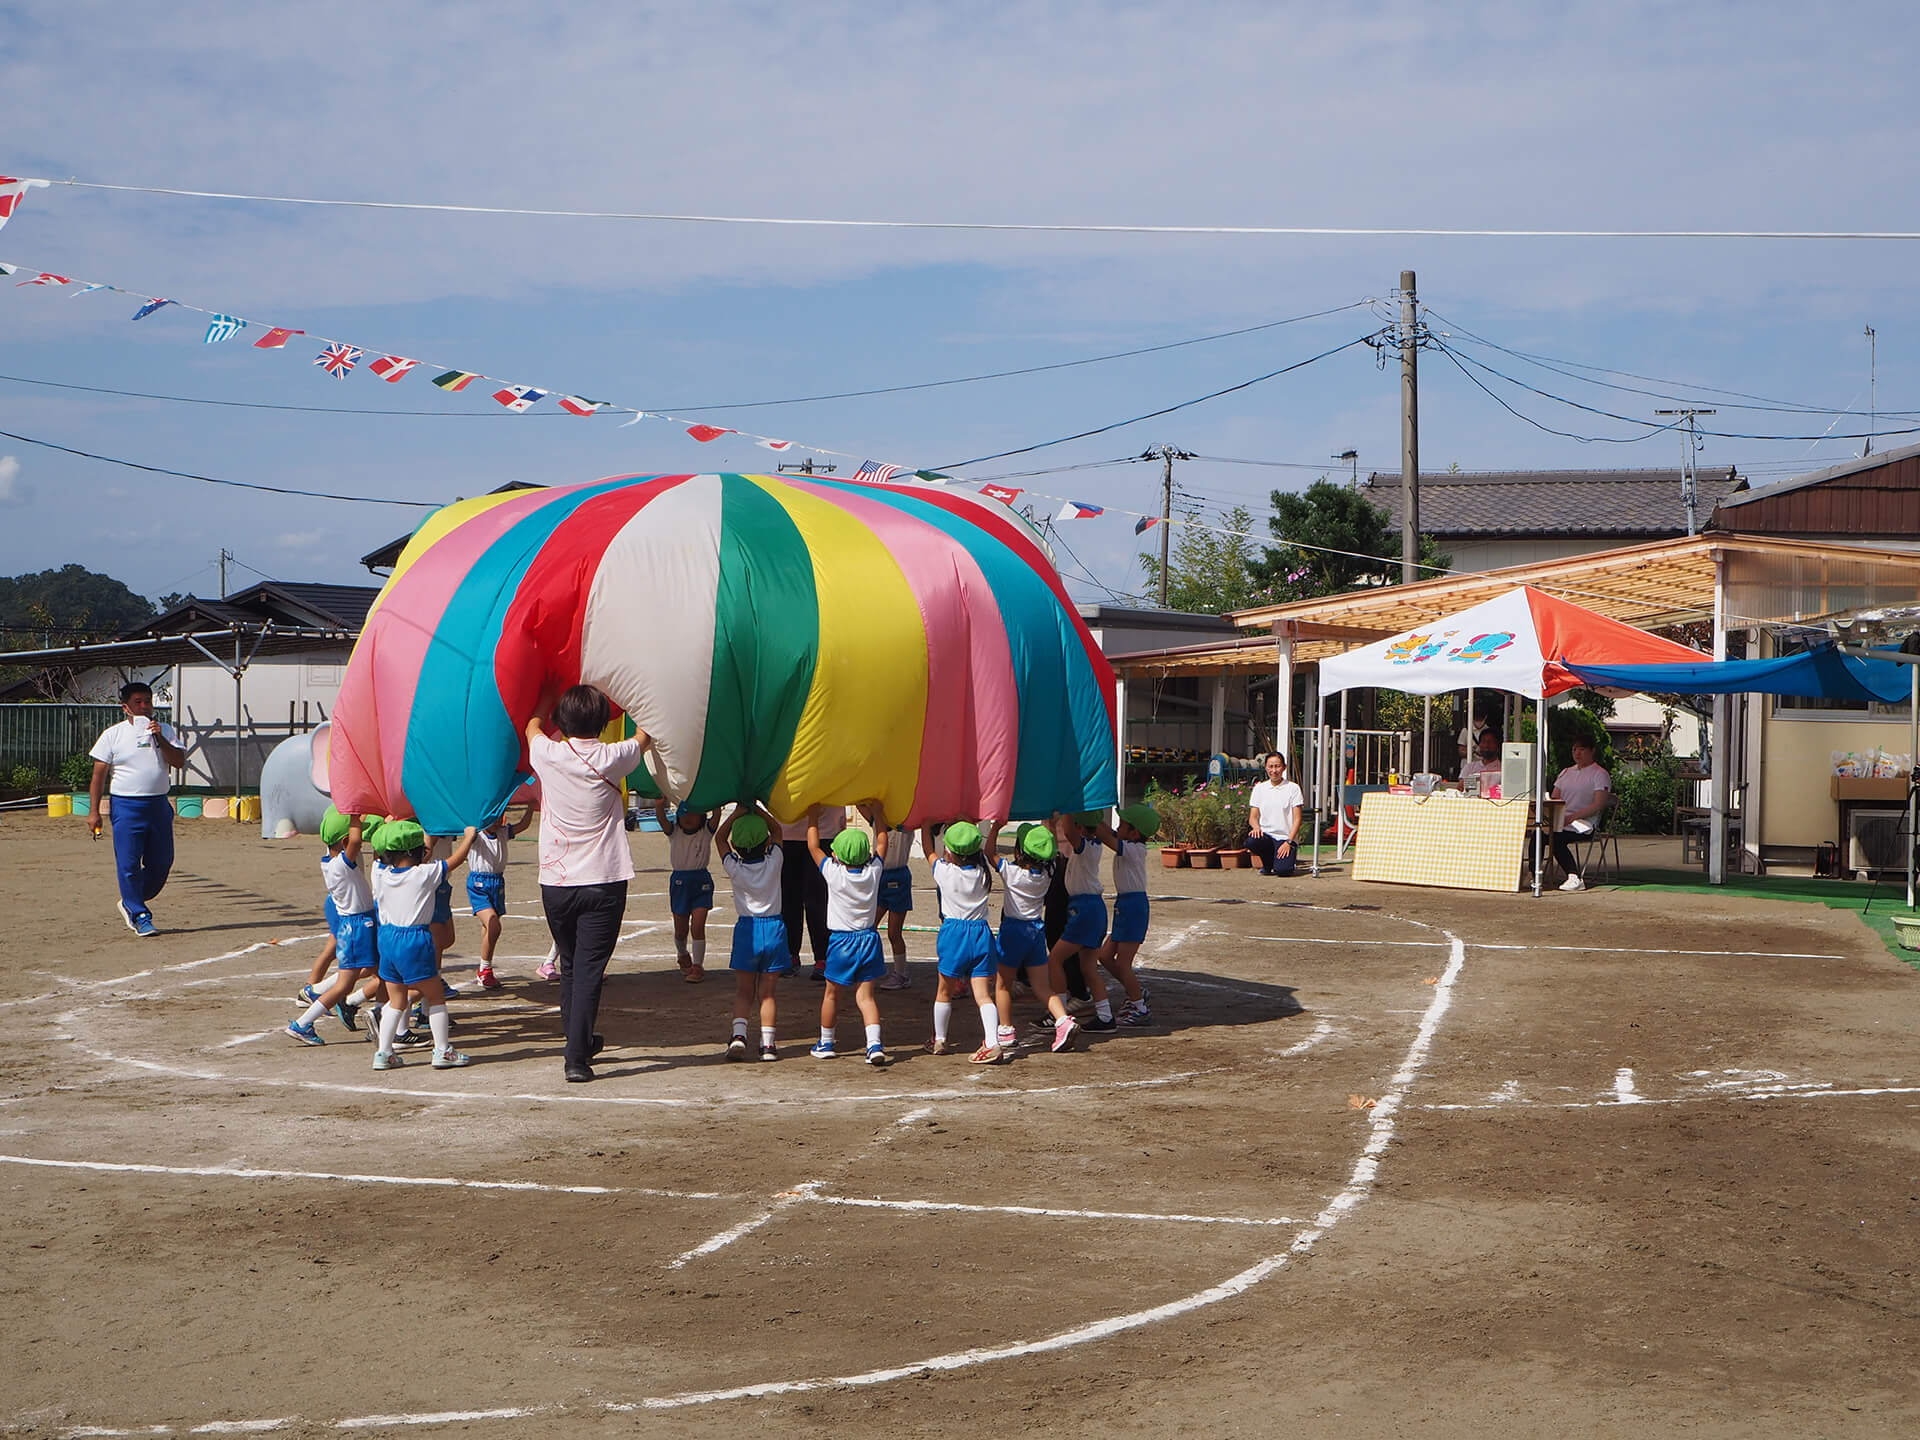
[{"x1": 1250, "y1": 476, "x2": 1453, "y2": 603}]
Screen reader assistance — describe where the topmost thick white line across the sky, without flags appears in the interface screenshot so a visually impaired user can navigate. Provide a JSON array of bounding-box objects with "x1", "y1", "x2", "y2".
[{"x1": 46, "y1": 179, "x2": 1920, "y2": 240}]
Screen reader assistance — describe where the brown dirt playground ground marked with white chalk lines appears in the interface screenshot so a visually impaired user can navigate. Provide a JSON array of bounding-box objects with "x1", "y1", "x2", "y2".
[{"x1": 0, "y1": 816, "x2": 1920, "y2": 1440}]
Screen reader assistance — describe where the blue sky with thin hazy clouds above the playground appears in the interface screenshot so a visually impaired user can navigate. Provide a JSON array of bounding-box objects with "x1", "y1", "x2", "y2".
[{"x1": 0, "y1": 0, "x2": 1920, "y2": 599}]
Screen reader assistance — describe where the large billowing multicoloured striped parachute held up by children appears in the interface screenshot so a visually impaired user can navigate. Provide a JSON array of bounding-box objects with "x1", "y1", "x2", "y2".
[{"x1": 330, "y1": 474, "x2": 1116, "y2": 833}]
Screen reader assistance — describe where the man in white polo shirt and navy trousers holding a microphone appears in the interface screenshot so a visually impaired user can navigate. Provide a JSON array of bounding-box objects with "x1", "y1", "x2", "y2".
[{"x1": 86, "y1": 680, "x2": 186, "y2": 939}]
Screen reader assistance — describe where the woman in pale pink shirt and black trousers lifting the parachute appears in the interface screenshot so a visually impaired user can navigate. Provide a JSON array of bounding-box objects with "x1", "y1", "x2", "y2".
[{"x1": 526, "y1": 685, "x2": 653, "y2": 1085}]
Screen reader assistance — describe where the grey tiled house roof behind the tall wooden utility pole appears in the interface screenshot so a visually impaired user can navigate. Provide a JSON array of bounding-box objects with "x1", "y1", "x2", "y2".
[{"x1": 1361, "y1": 468, "x2": 1745, "y2": 540}]
